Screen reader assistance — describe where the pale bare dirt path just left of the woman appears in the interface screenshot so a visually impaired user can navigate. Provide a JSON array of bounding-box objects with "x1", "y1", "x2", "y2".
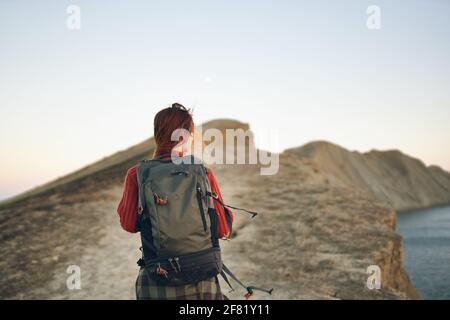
[{"x1": 46, "y1": 187, "x2": 140, "y2": 299}]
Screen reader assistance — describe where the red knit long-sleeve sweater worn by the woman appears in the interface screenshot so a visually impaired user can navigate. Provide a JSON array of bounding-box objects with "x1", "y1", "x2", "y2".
[{"x1": 117, "y1": 162, "x2": 233, "y2": 238}]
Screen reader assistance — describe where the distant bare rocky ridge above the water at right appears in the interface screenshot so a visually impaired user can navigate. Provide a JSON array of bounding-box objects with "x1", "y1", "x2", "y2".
[{"x1": 286, "y1": 141, "x2": 450, "y2": 210}]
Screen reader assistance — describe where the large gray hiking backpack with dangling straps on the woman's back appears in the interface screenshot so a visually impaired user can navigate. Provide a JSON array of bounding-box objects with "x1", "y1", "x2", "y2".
[{"x1": 137, "y1": 155, "x2": 271, "y2": 295}]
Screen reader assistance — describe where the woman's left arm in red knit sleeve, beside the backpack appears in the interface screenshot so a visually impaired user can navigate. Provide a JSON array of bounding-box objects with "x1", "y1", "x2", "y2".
[{"x1": 117, "y1": 166, "x2": 139, "y2": 233}]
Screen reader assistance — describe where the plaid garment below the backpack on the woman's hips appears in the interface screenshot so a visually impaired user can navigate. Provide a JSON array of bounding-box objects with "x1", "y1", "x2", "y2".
[{"x1": 136, "y1": 268, "x2": 227, "y2": 300}]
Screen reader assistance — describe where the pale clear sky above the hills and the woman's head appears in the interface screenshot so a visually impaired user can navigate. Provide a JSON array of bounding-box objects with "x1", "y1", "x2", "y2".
[{"x1": 0, "y1": 0, "x2": 450, "y2": 198}]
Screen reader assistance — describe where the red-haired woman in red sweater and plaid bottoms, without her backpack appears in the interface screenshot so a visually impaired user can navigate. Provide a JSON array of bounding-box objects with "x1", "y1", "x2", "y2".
[{"x1": 117, "y1": 103, "x2": 233, "y2": 300}]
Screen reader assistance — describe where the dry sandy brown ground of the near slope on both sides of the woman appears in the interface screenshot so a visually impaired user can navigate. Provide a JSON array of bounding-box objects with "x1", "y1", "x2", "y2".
[{"x1": 0, "y1": 151, "x2": 417, "y2": 299}]
